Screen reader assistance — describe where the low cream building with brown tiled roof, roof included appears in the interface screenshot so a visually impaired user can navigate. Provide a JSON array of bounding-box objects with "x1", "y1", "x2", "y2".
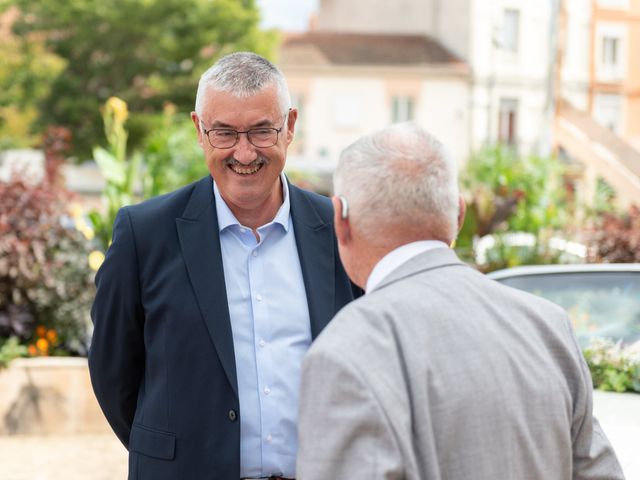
[{"x1": 278, "y1": 31, "x2": 470, "y2": 182}]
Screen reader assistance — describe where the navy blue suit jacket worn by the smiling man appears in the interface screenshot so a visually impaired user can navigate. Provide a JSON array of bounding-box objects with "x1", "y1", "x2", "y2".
[{"x1": 89, "y1": 177, "x2": 357, "y2": 480}]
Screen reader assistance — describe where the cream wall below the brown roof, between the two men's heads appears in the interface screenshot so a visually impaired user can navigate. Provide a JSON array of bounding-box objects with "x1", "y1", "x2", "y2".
[{"x1": 283, "y1": 67, "x2": 470, "y2": 171}]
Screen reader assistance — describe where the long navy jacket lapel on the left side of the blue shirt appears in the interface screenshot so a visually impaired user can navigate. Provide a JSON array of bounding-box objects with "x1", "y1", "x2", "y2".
[{"x1": 176, "y1": 177, "x2": 238, "y2": 395}]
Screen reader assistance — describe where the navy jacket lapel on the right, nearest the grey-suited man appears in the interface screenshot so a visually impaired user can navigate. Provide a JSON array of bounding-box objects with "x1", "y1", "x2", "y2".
[{"x1": 289, "y1": 184, "x2": 335, "y2": 338}]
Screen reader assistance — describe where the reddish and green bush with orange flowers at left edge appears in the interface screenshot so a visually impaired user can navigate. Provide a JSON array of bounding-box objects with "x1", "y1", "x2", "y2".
[{"x1": 0, "y1": 177, "x2": 93, "y2": 355}]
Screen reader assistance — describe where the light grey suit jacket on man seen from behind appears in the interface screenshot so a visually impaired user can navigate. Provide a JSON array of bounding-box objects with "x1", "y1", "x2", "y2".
[{"x1": 298, "y1": 249, "x2": 624, "y2": 480}]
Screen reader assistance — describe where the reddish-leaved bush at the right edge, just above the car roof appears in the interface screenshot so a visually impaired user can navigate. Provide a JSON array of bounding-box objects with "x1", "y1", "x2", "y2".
[{"x1": 588, "y1": 206, "x2": 640, "y2": 263}]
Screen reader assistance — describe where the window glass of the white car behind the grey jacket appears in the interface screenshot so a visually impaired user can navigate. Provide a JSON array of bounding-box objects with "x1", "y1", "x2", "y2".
[{"x1": 499, "y1": 272, "x2": 640, "y2": 346}]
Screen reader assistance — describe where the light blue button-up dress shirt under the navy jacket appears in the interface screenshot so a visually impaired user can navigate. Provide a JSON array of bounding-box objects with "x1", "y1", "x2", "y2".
[{"x1": 213, "y1": 175, "x2": 311, "y2": 477}]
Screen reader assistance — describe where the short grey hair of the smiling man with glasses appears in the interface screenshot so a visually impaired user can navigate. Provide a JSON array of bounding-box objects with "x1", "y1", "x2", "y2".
[{"x1": 195, "y1": 52, "x2": 291, "y2": 117}]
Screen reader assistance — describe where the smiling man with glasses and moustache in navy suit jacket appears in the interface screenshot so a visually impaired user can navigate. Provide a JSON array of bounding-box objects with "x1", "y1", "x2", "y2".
[{"x1": 89, "y1": 53, "x2": 354, "y2": 480}]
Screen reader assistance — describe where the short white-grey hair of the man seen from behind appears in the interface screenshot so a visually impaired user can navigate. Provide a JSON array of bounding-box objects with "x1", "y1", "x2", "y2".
[{"x1": 333, "y1": 123, "x2": 459, "y2": 242}]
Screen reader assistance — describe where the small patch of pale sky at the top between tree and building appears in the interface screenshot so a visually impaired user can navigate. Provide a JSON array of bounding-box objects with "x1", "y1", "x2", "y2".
[{"x1": 257, "y1": 0, "x2": 320, "y2": 32}]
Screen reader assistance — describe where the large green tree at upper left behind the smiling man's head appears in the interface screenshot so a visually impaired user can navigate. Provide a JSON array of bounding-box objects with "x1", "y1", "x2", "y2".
[{"x1": 5, "y1": 0, "x2": 277, "y2": 154}]
